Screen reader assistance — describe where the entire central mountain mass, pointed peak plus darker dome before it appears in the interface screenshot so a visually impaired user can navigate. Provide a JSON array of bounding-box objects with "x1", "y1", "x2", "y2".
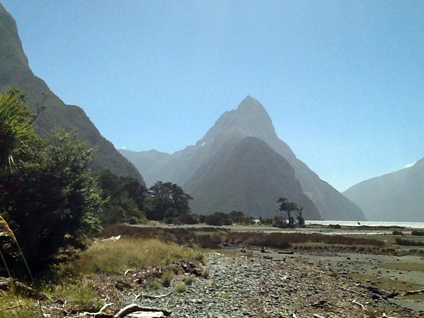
[{"x1": 120, "y1": 96, "x2": 364, "y2": 220}]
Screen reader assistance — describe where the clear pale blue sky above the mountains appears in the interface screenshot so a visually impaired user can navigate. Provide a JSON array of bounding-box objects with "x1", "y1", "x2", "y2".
[{"x1": 0, "y1": 0, "x2": 424, "y2": 191}]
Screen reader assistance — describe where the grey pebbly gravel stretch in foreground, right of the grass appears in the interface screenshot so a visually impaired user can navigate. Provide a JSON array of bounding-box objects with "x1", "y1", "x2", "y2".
[{"x1": 127, "y1": 253, "x2": 398, "y2": 318}]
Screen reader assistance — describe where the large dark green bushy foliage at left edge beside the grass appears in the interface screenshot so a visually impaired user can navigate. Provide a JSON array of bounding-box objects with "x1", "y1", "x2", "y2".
[{"x1": 0, "y1": 92, "x2": 102, "y2": 273}]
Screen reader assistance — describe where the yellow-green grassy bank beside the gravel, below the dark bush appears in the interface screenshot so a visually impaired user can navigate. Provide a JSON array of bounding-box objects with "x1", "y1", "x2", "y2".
[{"x1": 0, "y1": 237, "x2": 202, "y2": 318}]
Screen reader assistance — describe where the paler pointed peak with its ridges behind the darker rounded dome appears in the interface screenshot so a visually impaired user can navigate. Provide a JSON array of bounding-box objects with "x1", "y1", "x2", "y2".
[{"x1": 121, "y1": 96, "x2": 365, "y2": 220}]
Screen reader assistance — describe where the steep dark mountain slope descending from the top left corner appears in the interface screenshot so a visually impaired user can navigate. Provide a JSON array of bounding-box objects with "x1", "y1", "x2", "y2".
[{"x1": 0, "y1": 4, "x2": 142, "y2": 180}]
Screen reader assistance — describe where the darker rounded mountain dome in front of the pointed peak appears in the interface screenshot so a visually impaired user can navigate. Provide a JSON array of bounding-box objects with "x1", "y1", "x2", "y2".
[{"x1": 185, "y1": 137, "x2": 320, "y2": 219}]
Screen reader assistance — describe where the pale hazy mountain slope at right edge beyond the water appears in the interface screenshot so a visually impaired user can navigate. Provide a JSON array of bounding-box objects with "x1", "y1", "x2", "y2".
[{"x1": 344, "y1": 159, "x2": 424, "y2": 222}]
